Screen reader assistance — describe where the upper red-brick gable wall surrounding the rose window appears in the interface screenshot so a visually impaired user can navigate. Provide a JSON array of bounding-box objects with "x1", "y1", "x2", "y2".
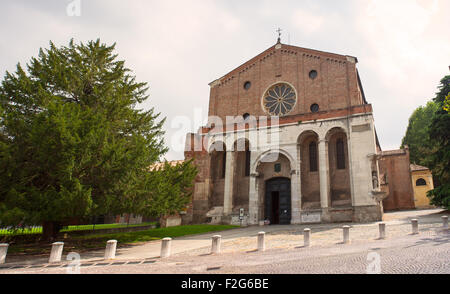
[{"x1": 209, "y1": 45, "x2": 363, "y2": 121}]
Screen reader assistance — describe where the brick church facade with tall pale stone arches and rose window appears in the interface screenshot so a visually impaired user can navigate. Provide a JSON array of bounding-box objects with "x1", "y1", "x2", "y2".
[{"x1": 183, "y1": 42, "x2": 386, "y2": 225}]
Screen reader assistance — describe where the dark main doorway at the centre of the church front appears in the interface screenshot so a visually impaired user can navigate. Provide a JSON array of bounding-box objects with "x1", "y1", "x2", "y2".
[{"x1": 264, "y1": 178, "x2": 291, "y2": 225}]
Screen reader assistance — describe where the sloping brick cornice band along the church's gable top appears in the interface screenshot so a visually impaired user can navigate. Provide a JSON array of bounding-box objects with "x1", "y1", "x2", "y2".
[{"x1": 209, "y1": 43, "x2": 358, "y2": 86}]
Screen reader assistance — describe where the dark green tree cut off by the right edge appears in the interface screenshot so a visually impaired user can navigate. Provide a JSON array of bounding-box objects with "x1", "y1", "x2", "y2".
[{"x1": 428, "y1": 75, "x2": 450, "y2": 209}]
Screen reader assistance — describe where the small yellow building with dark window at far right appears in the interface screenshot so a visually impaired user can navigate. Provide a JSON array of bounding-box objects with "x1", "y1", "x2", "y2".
[{"x1": 411, "y1": 164, "x2": 434, "y2": 208}]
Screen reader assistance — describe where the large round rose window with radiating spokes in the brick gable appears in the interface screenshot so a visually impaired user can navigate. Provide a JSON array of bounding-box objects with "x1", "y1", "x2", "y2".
[{"x1": 263, "y1": 83, "x2": 297, "y2": 116}]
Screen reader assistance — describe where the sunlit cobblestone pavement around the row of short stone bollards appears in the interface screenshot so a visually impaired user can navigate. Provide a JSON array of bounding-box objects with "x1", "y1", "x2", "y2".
[{"x1": 0, "y1": 211, "x2": 450, "y2": 274}]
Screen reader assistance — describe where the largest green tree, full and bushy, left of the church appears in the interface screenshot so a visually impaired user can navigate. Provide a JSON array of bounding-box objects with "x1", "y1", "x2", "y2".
[{"x1": 0, "y1": 40, "x2": 173, "y2": 237}]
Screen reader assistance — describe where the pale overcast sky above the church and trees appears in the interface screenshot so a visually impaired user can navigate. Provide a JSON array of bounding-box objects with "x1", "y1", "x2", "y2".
[{"x1": 0, "y1": 0, "x2": 450, "y2": 160}]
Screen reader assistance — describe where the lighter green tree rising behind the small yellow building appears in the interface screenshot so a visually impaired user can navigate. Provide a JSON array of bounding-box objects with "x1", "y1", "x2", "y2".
[{"x1": 401, "y1": 101, "x2": 438, "y2": 166}]
